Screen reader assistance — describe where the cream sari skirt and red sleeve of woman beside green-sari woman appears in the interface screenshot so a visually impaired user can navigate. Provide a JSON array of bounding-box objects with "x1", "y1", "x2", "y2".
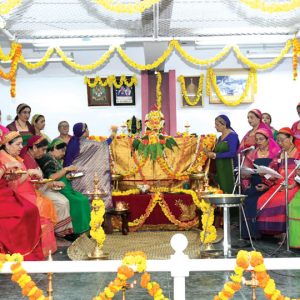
[{"x1": 21, "y1": 146, "x2": 73, "y2": 237}]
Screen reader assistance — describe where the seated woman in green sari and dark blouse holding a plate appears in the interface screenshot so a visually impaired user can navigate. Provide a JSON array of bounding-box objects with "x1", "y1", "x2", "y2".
[{"x1": 37, "y1": 139, "x2": 90, "y2": 234}]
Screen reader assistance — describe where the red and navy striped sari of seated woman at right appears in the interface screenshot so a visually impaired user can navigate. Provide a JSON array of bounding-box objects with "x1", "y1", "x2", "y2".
[{"x1": 257, "y1": 155, "x2": 299, "y2": 234}]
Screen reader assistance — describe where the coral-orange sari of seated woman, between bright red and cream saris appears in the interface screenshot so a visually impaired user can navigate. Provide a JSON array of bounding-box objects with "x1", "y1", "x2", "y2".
[{"x1": 0, "y1": 150, "x2": 57, "y2": 256}]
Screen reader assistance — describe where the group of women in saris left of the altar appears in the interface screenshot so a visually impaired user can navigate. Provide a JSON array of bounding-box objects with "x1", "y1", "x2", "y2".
[{"x1": 0, "y1": 104, "x2": 116, "y2": 260}]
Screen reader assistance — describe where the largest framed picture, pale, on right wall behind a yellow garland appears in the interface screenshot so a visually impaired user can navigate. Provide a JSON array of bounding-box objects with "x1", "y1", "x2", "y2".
[{"x1": 208, "y1": 69, "x2": 254, "y2": 104}]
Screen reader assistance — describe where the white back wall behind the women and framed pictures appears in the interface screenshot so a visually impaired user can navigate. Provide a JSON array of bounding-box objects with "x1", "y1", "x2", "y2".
[{"x1": 0, "y1": 47, "x2": 300, "y2": 138}]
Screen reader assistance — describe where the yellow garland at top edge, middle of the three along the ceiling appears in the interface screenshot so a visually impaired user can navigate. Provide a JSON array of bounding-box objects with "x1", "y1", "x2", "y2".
[{"x1": 94, "y1": 0, "x2": 160, "y2": 14}]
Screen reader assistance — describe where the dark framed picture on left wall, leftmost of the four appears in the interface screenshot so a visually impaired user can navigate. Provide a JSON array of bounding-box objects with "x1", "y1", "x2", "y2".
[{"x1": 87, "y1": 78, "x2": 111, "y2": 106}]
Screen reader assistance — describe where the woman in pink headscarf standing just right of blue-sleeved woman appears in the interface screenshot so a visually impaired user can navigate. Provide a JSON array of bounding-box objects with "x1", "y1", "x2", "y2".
[{"x1": 238, "y1": 109, "x2": 273, "y2": 152}]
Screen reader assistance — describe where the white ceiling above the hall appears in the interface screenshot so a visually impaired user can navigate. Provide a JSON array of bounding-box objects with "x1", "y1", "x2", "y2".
[{"x1": 0, "y1": 0, "x2": 300, "y2": 62}]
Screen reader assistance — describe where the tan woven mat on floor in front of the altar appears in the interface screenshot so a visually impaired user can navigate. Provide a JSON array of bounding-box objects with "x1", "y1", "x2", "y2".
[{"x1": 67, "y1": 230, "x2": 223, "y2": 260}]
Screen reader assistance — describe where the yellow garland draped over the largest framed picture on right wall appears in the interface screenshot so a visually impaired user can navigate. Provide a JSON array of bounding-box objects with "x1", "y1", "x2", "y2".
[{"x1": 206, "y1": 69, "x2": 257, "y2": 106}]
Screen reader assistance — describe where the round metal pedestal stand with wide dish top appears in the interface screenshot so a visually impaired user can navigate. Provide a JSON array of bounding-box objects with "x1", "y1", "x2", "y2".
[{"x1": 202, "y1": 194, "x2": 247, "y2": 257}]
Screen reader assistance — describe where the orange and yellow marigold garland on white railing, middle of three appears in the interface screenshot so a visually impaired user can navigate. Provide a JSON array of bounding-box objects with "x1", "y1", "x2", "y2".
[{"x1": 93, "y1": 251, "x2": 168, "y2": 300}]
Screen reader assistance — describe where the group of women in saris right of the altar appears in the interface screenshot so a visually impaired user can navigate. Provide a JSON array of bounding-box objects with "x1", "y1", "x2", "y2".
[{"x1": 207, "y1": 103, "x2": 300, "y2": 248}]
